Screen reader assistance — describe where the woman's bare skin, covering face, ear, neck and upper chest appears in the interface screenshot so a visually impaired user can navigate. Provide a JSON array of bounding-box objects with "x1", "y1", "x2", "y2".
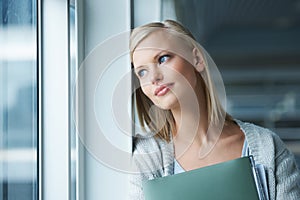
[{"x1": 133, "y1": 31, "x2": 245, "y2": 171}]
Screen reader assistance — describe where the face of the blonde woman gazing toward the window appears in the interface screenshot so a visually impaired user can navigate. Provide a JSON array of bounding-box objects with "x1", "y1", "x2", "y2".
[{"x1": 133, "y1": 31, "x2": 198, "y2": 109}]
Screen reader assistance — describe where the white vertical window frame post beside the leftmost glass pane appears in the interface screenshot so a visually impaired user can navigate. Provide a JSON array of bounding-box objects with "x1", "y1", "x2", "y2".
[{"x1": 37, "y1": 0, "x2": 71, "y2": 200}]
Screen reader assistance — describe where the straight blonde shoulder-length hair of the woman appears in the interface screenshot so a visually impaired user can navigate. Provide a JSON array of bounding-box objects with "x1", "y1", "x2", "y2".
[{"x1": 130, "y1": 20, "x2": 232, "y2": 142}]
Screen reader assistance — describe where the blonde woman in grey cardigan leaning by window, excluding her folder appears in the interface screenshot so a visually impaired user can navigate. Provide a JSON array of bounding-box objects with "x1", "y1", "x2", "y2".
[{"x1": 130, "y1": 20, "x2": 300, "y2": 200}]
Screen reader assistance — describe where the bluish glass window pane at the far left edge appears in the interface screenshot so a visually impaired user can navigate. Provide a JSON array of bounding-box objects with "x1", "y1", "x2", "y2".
[{"x1": 0, "y1": 0, "x2": 37, "y2": 200}]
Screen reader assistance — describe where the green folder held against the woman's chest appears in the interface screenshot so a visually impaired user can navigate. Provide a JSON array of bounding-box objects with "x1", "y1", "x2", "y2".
[{"x1": 143, "y1": 156, "x2": 259, "y2": 200}]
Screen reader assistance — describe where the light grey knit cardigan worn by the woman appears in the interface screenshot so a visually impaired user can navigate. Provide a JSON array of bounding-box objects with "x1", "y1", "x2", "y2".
[{"x1": 129, "y1": 120, "x2": 300, "y2": 200}]
